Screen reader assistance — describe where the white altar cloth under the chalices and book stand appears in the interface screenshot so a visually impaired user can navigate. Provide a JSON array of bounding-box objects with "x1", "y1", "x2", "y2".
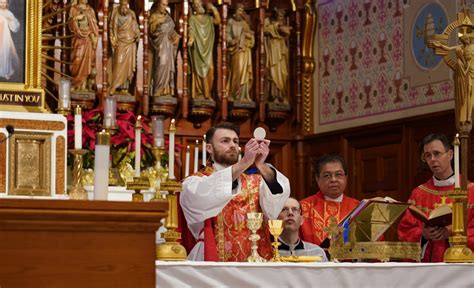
[{"x1": 156, "y1": 261, "x2": 474, "y2": 288}]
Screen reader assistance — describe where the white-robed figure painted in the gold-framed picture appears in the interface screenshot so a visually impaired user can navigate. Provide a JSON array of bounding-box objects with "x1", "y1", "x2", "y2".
[{"x1": 0, "y1": 0, "x2": 20, "y2": 80}]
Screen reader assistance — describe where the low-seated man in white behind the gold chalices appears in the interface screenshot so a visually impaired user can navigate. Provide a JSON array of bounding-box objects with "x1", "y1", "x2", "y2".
[{"x1": 278, "y1": 197, "x2": 328, "y2": 262}]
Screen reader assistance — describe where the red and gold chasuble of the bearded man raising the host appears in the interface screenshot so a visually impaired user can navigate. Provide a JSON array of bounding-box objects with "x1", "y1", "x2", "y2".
[{"x1": 198, "y1": 167, "x2": 273, "y2": 261}]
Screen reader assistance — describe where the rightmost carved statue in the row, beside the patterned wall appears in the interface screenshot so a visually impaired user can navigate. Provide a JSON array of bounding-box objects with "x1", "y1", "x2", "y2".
[{"x1": 264, "y1": 9, "x2": 291, "y2": 103}]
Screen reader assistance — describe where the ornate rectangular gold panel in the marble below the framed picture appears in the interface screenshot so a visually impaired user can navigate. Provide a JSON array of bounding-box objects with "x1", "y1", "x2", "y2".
[{"x1": 8, "y1": 131, "x2": 53, "y2": 196}]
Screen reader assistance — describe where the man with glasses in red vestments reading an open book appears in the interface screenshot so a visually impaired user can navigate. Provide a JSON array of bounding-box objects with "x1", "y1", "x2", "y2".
[{"x1": 398, "y1": 134, "x2": 474, "y2": 262}]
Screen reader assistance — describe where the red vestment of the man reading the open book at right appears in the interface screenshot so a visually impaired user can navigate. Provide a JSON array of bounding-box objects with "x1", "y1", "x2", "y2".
[{"x1": 398, "y1": 178, "x2": 474, "y2": 262}]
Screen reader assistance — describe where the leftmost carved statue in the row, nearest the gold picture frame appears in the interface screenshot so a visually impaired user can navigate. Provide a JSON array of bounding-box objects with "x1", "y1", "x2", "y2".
[{"x1": 68, "y1": 0, "x2": 99, "y2": 91}]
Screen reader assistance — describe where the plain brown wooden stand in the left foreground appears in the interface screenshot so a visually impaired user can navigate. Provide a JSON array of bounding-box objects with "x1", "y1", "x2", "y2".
[{"x1": 0, "y1": 199, "x2": 168, "y2": 288}]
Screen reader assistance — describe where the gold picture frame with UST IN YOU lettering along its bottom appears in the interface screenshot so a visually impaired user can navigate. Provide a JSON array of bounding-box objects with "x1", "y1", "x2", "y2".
[{"x1": 0, "y1": 0, "x2": 45, "y2": 112}]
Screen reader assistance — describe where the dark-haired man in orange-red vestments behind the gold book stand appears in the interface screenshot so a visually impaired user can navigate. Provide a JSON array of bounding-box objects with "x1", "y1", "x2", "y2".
[{"x1": 300, "y1": 154, "x2": 359, "y2": 248}]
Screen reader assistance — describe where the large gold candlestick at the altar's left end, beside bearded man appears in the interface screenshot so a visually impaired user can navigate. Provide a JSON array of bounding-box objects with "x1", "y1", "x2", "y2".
[{"x1": 156, "y1": 179, "x2": 187, "y2": 261}]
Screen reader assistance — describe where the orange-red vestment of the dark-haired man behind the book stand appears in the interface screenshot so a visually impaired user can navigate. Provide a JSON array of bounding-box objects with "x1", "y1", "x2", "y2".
[{"x1": 300, "y1": 191, "x2": 359, "y2": 245}]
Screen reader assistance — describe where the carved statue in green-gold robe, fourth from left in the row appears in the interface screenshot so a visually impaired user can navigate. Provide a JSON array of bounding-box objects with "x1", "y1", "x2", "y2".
[{"x1": 188, "y1": 0, "x2": 221, "y2": 99}]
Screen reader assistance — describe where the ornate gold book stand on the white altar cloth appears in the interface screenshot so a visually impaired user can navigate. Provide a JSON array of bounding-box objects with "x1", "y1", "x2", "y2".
[{"x1": 325, "y1": 197, "x2": 421, "y2": 262}]
